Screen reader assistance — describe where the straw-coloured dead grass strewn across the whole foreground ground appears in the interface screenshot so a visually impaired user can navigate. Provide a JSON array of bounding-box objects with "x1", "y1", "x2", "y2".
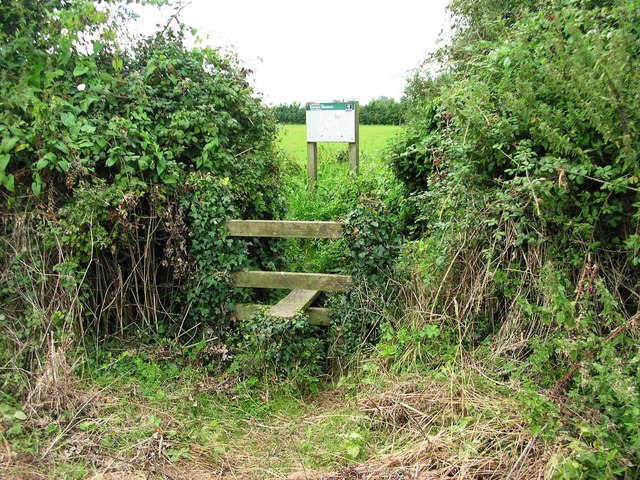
[{"x1": 0, "y1": 344, "x2": 557, "y2": 480}]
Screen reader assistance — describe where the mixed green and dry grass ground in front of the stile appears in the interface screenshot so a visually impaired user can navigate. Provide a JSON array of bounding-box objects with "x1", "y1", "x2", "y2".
[{"x1": 0, "y1": 344, "x2": 553, "y2": 480}]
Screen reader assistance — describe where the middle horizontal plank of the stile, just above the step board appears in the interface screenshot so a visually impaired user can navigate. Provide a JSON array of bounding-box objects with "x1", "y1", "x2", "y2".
[{"x1": 233, "y1": 271, "x2": 353, "y2": 292}]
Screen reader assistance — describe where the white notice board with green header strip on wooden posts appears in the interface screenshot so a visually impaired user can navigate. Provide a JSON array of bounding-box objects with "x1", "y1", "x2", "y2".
[{"x1": 307, "y1": 102, "x2": 356, "y2": 143}]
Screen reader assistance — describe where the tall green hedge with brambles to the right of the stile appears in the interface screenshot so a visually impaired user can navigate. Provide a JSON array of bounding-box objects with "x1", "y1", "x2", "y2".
[{"x1": 385, "y1": 0, "x2": 640, "y2": 478}]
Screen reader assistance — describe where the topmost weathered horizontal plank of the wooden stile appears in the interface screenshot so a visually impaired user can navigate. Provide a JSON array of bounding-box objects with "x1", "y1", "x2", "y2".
[{"x1": 225, "y1": 220, "x2": 342, "y2": 239}]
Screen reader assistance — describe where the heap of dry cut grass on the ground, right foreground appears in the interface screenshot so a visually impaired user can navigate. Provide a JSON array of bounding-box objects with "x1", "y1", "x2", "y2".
[{"x1": 298, "y1": 376, "x2": 558, "y2": 480}]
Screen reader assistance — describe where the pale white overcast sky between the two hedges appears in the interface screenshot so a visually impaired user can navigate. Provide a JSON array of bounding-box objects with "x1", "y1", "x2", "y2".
[{"x1": 129, "y1": 0, "x2": 448, "y2": 104}]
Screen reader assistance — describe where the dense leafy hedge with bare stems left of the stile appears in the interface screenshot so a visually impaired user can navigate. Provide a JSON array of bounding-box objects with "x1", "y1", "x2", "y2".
[{"x1": 0, "y1": 0, "x2": 284, "y2": 394}]
